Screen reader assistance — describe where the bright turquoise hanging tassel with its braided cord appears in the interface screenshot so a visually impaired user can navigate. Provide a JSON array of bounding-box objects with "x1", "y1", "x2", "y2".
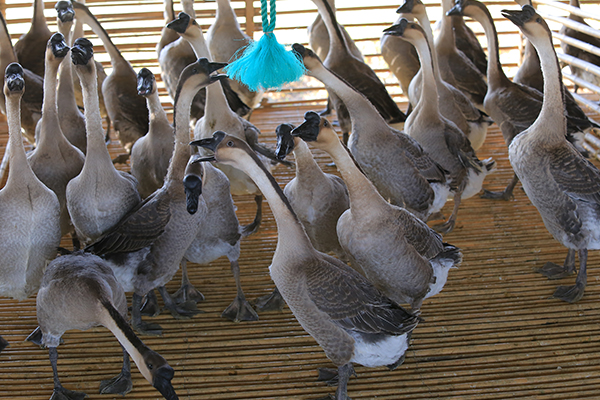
[{"x1": 225, "y1": 0, "x2": 305, "y2": 91}]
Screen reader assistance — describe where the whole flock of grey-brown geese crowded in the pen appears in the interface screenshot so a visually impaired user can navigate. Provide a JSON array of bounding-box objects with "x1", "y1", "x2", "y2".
[{"x1": 0, "y1": 0, "x2": 600, "y2": 400}]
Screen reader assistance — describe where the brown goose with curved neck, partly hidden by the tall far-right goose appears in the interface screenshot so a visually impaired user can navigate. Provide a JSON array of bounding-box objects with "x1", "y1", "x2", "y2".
[{"x1": 449, "y1": 0, "x2": 592, "y2": 200}]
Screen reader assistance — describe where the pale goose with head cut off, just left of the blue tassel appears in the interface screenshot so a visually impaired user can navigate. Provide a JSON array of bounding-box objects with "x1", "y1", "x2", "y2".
[{"x1": 206, "y1": 0, "x2": 264, "y2": 110}]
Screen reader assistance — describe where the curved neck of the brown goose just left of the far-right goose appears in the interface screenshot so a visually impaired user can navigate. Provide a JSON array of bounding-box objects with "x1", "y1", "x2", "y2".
[{"x1": 469, "y1": 3, "x2": 509, "y2": 88}]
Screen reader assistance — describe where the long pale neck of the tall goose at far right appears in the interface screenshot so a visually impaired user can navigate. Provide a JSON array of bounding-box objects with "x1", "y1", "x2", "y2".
[{"x1": 529, "y1": 35, "x2": 567, "y2": 143}]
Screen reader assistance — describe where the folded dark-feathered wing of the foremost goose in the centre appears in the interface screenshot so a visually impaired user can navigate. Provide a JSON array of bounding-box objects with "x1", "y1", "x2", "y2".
[{"x1": 307, "y1": 255, "x2": 419, "y2": 335}]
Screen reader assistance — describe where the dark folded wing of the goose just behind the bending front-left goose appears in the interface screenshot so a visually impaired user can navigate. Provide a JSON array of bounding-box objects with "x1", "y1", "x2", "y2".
[{"x1": 85, "y1": 192, "x2": 171, "y2": 255}]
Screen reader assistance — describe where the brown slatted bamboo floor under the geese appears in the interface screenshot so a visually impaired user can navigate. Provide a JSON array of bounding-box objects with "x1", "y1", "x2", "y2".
[{"x1": 0, "y1": 101, "x2": 600, "y2": 400}]
